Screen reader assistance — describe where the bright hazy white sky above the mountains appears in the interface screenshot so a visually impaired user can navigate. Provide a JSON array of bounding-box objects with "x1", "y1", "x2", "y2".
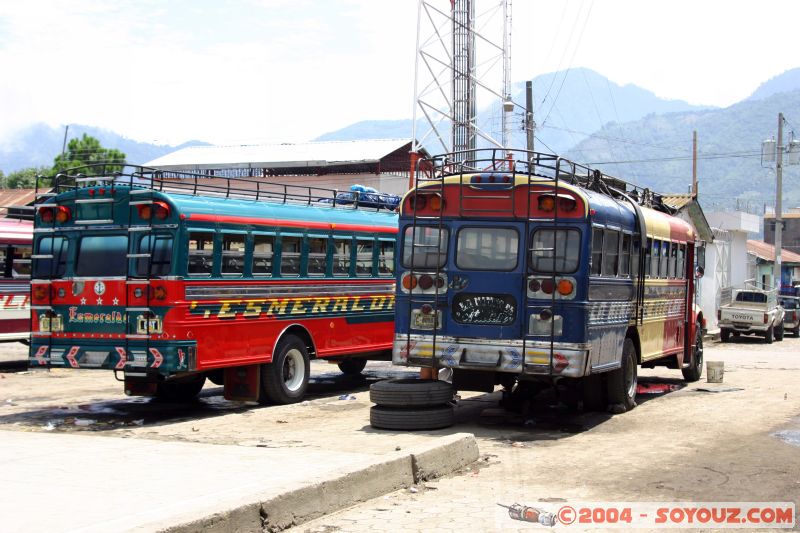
[{"x1": 0, "y1": 0, "x2": 800, "y2": 144}]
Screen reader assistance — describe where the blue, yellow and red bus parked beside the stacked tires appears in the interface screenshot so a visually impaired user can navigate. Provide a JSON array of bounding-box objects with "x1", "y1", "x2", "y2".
[{"x1": 393, "y1": 150, "x2": 704, "y2": 409}]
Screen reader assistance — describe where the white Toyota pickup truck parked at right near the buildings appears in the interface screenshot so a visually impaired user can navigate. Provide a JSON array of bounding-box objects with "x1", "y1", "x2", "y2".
[{"x1": 717, "y1": 289, "x2": 784, "y2": 344}]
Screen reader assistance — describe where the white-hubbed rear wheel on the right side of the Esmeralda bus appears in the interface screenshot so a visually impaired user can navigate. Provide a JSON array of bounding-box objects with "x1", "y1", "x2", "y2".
[{"x1": 261, "y1": 335, "x2": 311, "y2": 404}]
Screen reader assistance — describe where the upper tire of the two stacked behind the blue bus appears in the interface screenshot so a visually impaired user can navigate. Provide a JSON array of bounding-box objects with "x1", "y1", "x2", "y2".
[{"x1": 369, "y1": 378, "x2": 455, "y2": 407}]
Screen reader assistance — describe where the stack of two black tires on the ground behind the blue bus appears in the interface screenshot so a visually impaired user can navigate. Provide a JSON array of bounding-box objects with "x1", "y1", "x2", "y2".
[{"x1": 369, "y1": 379, "x2": 455, "y2": 430}]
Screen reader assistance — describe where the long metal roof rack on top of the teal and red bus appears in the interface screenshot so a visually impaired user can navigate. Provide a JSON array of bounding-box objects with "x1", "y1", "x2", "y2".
[{"x1": 36, "y1": 163, "x2": 399, "y2": 210}]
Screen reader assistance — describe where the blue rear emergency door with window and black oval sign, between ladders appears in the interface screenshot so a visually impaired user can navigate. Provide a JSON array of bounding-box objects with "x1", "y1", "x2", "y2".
[{"x1": 447, "y1": 220, "x2": 525, "y2": 371}]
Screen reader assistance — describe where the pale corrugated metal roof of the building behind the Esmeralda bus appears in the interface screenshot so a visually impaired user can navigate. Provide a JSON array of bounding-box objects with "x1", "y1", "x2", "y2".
[{"x1": 145, "y1": 139, "x2": 411, "y2": 170}]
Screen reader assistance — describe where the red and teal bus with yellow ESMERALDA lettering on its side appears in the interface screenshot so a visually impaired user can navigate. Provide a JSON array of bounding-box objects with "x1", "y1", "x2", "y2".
[{"x1": 30, "y1": 166, "x2": 397, "y2": 403}]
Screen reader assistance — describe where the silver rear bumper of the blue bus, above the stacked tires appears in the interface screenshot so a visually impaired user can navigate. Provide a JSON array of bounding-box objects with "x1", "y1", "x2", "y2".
[{"x1": 392, "y1": 334, "x2": 590, "y2": 378}]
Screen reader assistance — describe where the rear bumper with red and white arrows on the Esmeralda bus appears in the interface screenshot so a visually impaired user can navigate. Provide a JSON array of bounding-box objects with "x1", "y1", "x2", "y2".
[{"x1": 29, "y1": 337, "x2": 197, "y2": 376}]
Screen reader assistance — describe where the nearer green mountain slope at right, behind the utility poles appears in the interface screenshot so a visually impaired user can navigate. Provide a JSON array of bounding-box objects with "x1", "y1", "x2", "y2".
[{"x1": 565, "y1": 90, "x2": 800, "y2": 212}]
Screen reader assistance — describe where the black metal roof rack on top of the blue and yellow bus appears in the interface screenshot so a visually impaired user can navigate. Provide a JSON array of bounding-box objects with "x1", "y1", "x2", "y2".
[{"x1": 418, "y1": 148, "x2": 675, "y2": 214}]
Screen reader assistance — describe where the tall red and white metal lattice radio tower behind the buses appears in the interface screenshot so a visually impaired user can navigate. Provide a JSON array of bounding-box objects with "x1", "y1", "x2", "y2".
[{"x1": 412, "y1": 0, "x2": 524, "y2": 164}]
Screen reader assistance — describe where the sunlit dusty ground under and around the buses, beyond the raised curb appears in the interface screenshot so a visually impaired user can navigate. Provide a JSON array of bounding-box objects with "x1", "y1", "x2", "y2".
[{"x1": 0, "y1": 337, "x2": 800, "y2": 531}]
